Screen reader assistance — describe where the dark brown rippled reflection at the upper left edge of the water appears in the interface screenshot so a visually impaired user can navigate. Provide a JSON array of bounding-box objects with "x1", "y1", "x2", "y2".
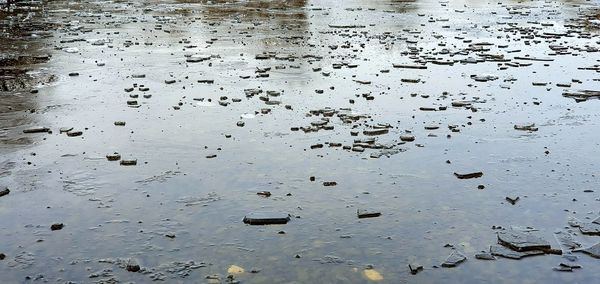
[{"x1": 0, "y1": 3, "x2": 54, "y2": 144}]
